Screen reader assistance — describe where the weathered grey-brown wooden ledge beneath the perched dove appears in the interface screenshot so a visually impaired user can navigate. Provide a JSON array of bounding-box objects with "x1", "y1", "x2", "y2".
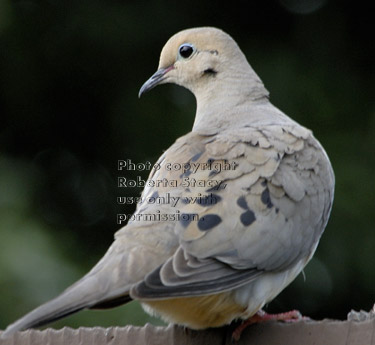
[{"x1": 0, "y1": 319, "x2": 375, "y2": 345}]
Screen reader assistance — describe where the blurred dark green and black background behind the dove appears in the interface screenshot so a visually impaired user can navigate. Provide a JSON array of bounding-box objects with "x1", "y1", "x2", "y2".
[{"x1": 0, "y1": 0, "x2": 375, "y2": 328}]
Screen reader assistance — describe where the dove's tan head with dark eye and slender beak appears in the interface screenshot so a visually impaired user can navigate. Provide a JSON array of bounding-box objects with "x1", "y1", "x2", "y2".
[{"x1": 139, "y1": 27, "x2": 250, "y2": 96}]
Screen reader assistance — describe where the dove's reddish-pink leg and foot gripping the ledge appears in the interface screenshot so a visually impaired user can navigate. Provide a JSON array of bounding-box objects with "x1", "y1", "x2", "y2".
[{"x1": 232, "y1": 309, "x2": 310, "y2": 341}]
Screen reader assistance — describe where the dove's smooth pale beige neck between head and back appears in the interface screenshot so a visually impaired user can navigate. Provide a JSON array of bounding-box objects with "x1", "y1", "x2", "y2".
[{"x1": 193, "y1": 70, "x2": 268, "y2": 134}]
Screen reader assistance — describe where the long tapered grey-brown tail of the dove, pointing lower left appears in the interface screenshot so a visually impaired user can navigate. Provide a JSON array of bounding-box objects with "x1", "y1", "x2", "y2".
[{"x1": 2, "y1": 227, "x2": 175, "y2": 337}]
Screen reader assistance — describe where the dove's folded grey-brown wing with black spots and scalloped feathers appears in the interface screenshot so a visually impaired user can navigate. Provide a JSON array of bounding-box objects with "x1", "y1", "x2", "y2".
[{"x1": 131, "y1": 124, "x2": 334, "y2": 299}]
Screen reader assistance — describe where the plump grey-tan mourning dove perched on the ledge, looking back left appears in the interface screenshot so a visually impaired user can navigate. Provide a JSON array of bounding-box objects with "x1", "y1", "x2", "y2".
[{"x1": 5, "y1": 27, "x2": 334, "y2": 335}]
